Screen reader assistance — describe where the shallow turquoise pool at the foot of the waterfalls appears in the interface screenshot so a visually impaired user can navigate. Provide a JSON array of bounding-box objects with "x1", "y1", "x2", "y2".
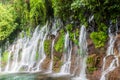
[{"x1": 0, "y1": 73, "x2": 71, "y2": 80}]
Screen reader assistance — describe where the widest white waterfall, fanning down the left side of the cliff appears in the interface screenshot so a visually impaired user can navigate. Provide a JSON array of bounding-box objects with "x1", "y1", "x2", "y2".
[{"x1": 0, "y1": 24, "x2": 48, "y2": 72}]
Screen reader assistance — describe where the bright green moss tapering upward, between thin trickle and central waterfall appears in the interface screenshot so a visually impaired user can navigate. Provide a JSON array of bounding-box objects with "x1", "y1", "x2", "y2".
[{"x1": 54, "y1": 30, "x2": 64, "y2": 53}]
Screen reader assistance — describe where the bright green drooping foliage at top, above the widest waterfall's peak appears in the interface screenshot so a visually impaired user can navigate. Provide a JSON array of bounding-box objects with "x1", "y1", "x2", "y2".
[{"x1": 30, "y1": 0, "x2": 46, "y2": 25}]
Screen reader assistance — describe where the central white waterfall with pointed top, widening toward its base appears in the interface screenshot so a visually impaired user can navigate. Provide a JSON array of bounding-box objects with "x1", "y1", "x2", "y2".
[{"x1": 60, "y1": 32, "x2": 72, "y2": 74}]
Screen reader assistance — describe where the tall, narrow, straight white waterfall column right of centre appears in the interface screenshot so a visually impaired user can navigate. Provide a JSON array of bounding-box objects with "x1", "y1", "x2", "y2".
[{"x1": 73, "y1": 25, "x2": 88, "y2": 80}]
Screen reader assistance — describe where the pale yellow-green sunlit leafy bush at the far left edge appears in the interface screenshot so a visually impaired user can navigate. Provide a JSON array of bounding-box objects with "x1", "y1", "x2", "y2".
[{"x1": 0, "y1": 4, "x2": 17, "y2": 40}]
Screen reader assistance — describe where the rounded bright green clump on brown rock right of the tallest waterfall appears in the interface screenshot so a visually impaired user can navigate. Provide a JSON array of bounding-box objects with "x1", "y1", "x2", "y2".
[{"x1": 90, "y1": 22, "x2": 108, "y2": 48}]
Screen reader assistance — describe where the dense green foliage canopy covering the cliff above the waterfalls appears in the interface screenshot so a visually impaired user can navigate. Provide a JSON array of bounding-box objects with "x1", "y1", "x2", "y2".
[{"x1": 0, "y1": 0, "x2": 120, "y2": 49}]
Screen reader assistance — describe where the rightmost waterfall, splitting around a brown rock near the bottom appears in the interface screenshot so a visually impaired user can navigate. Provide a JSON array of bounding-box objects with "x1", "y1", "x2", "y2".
[{"x1": 100, "y1": 28, "x2": 119, "y2": 80}]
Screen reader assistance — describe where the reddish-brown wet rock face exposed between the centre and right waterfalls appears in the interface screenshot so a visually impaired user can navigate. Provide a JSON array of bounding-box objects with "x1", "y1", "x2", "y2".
[{"x1": 38, "y1": 31, "x2": 120, "y2": 80}]
